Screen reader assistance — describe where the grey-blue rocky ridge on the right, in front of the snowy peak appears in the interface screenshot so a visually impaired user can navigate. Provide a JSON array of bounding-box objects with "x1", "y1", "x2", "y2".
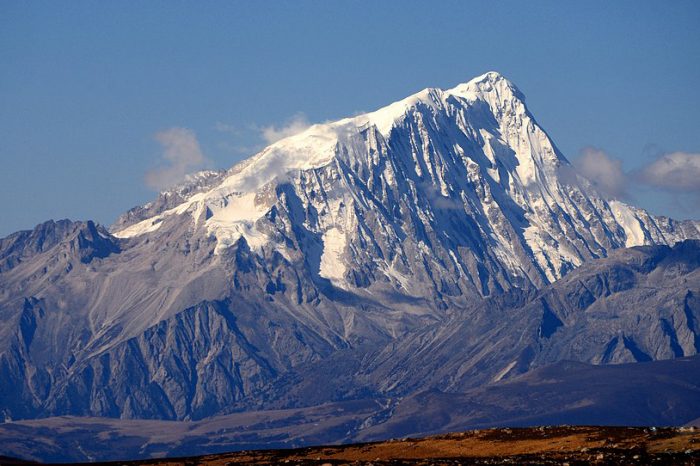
[{"x1": 252, "y1": 240, "x2": 700, "y2": 407}]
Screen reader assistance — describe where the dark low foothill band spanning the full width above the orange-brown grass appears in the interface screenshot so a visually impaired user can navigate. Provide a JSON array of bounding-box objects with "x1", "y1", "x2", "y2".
[{"x1": 5, "y1": 356, "x2": 700, "y2": 462}]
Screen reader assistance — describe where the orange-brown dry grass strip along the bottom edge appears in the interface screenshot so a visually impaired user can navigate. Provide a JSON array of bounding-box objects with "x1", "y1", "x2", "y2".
[{"x1": 6, "y1": 426, "x2": 700, "y2": 466}]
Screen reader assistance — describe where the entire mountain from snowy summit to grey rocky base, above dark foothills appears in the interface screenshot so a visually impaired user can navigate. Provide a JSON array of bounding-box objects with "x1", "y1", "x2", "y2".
[{"x1": 0, "y1": 73, "x2": 700, "y2": 419}]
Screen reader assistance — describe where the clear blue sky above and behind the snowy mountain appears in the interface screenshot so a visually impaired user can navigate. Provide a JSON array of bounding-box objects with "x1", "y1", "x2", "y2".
[{"x1": 0, "y1": 0, "x2": 700, "y2": 235}]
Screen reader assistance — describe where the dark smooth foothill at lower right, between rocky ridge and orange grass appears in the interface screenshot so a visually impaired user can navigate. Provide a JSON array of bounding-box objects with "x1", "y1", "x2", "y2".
[{"x1": 357, "y1": 356, "x2": 700, "y2": 441}]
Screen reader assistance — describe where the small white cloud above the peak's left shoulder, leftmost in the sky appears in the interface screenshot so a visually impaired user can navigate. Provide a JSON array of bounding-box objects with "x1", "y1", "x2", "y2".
[{"x1": 146, "y1": 128, "x2": 209, "y2": 190}]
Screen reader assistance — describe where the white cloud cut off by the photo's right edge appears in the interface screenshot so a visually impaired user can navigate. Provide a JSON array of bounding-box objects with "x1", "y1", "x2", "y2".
[{"x1": 634, "y1": 152, "x2": 700, "y2": 192}]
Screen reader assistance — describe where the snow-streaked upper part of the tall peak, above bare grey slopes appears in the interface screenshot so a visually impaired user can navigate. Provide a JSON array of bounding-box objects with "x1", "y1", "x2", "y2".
[{"x1": 114, "y1": 72, "x2": 698, "y2": 295}]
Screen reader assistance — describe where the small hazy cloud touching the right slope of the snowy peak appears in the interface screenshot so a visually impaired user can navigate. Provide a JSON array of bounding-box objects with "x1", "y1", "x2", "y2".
[{"x1": 574, "y1": 147, "x2": 629, "y2": 198}]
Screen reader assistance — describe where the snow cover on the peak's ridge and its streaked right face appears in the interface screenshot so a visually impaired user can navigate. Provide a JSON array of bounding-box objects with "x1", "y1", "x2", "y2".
[{"x1": 116, "y1": 72, "x2": 696, "y2": 290}]
